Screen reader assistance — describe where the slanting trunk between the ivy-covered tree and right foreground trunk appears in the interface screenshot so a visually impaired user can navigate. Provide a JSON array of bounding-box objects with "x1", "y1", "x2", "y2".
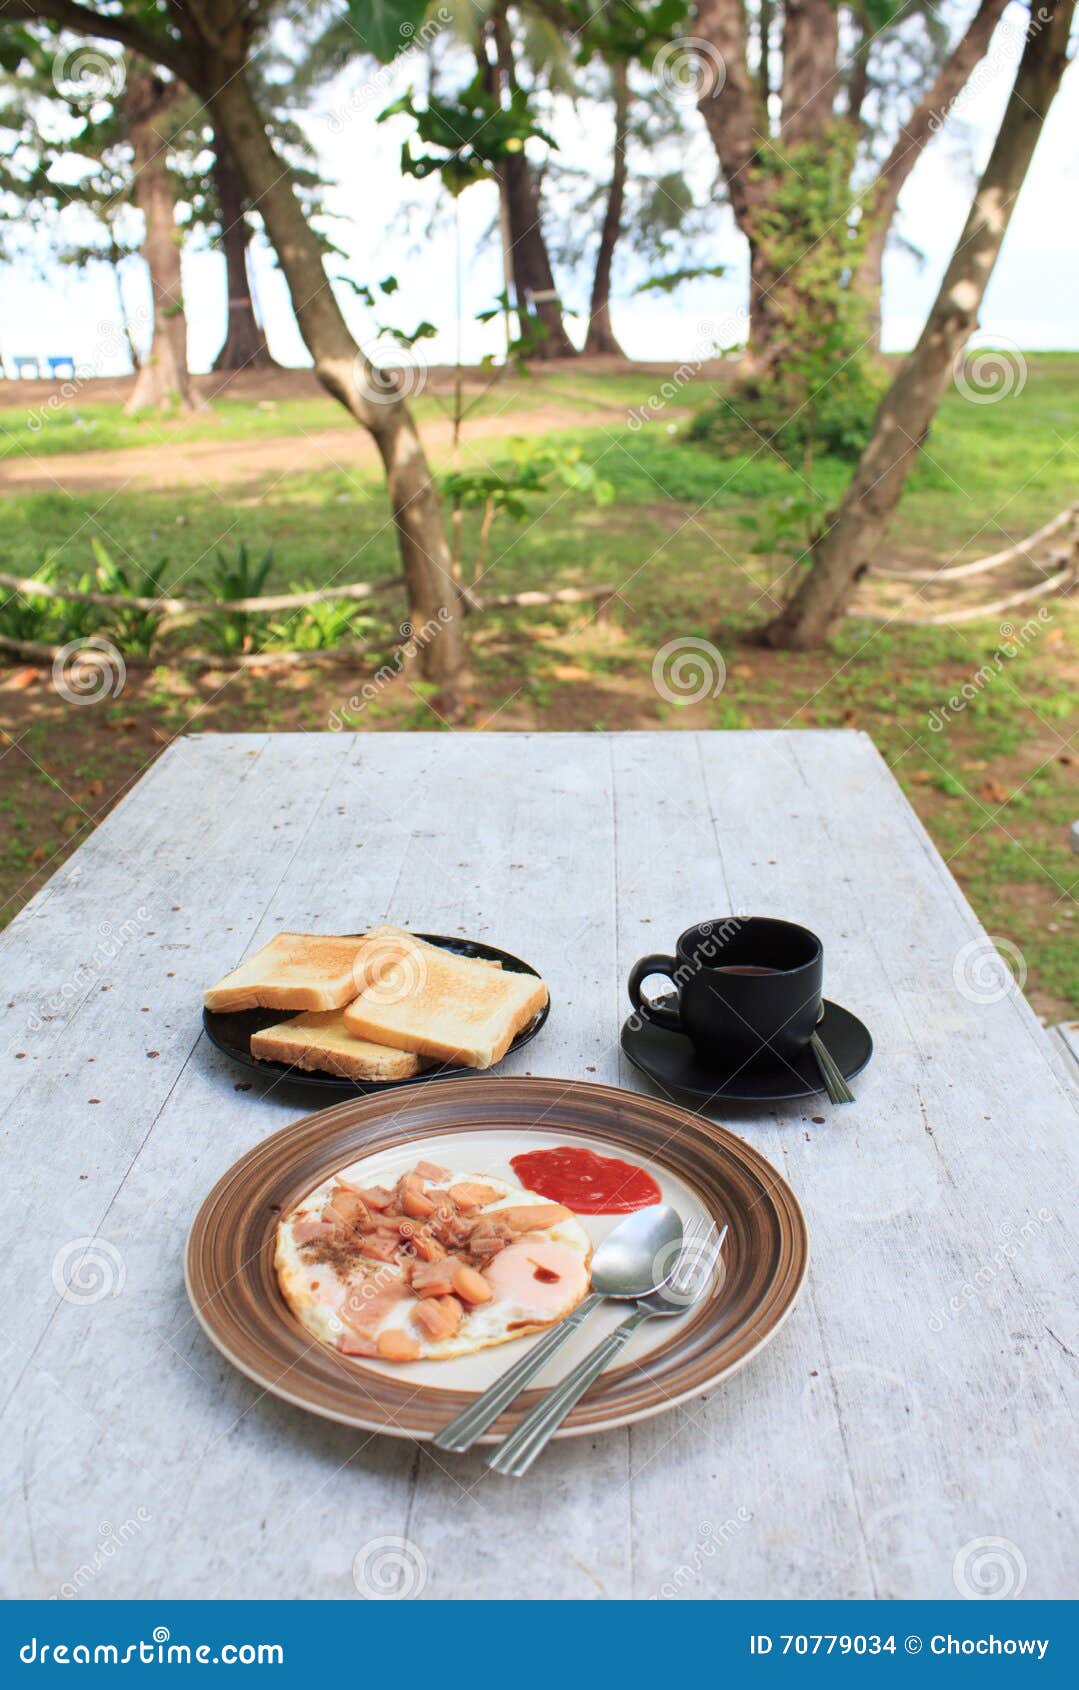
[{"x1": 852, "y1": 0, "x2": 1008, "y2": 352}]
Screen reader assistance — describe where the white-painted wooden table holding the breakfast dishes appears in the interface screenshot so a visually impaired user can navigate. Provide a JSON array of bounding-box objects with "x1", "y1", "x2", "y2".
[{"x1": 0, "y1": 732, "x2": 1079, "y2": 1599}]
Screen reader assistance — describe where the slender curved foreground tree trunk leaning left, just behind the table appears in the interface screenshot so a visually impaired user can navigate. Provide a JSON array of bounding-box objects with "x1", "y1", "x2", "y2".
[{"x1": 206, "y1": 59, "x2": 465, "y2": 690}]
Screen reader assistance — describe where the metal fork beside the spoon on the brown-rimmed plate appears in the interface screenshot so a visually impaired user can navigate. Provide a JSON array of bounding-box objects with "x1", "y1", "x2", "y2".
[{"x1": 487, "y1": 1220, "x2": 727, "y2": 1479}]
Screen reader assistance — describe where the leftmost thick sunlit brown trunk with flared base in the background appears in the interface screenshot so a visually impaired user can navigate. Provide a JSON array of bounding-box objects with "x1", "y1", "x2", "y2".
[{"x1": 123, "y1": 68, "x2": 194, "y2": 416}]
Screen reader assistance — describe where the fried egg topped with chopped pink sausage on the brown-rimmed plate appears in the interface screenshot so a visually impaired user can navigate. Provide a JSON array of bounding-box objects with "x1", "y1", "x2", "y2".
[{"x1": 274, "y1": 1159, "x2": 592, "y2": 1362}]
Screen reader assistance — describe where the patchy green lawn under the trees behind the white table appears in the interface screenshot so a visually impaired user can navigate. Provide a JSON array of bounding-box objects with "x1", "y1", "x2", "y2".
[{"x1": 0, "y1": 357, "x2": 1079, "y2": 1017}]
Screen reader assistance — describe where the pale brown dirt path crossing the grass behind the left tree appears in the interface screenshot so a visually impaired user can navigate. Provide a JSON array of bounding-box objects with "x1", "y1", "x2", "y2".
[{"x1": 0, "y1": 406, "x2": 635, "y2": 493}]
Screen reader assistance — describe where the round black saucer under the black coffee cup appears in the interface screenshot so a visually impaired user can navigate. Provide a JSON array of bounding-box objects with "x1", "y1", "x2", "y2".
[{"x1": 622, "y1": 995, "x2": 873, "y2": 1104}]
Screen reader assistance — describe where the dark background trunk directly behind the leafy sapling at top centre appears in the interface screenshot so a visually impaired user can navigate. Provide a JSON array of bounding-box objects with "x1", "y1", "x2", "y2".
[{"x1": 492, "y1": 12, "x2": 577, "y2": 358}]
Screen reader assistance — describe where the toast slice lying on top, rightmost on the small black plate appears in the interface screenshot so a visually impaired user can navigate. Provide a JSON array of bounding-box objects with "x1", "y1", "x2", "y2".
[{"x1": 343, "y1": 926, "x2": 546, "y2": 1068}]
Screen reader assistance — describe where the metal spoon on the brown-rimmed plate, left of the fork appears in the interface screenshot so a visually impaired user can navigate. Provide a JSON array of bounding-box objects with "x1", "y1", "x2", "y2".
[{"x1": 431, "y1": 1203, "x2": 682, "y2": 1452}]
